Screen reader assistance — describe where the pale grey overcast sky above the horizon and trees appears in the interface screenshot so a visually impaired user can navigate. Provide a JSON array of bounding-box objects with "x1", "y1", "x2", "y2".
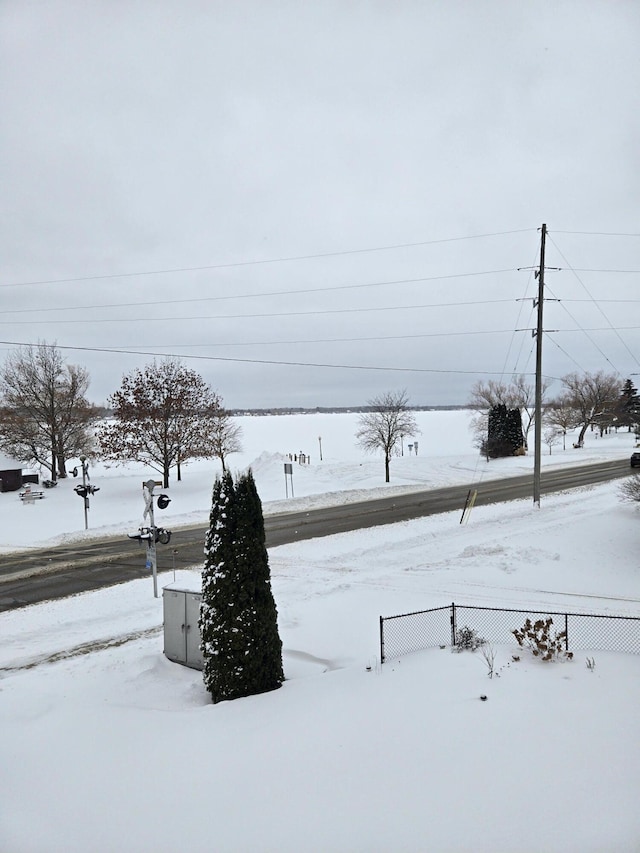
[{"x1": 0, "y1": 0, "x2": 640, "y2": 407}]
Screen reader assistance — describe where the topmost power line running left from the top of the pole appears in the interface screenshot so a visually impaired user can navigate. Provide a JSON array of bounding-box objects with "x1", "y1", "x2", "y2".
[{"x1": 0, "y1": 228, "x2": 533, "y2": 287}]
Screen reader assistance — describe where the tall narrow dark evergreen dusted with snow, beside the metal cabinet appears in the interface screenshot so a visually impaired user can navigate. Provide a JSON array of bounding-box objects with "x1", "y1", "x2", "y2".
[{"x1": 200, "y1": 471, "x2": 284, "y2": 702}]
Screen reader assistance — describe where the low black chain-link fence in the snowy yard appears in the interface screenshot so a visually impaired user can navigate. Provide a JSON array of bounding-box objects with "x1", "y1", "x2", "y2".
[{"x1": 380, "y1": 604, "x2": 640, "y2": 663}]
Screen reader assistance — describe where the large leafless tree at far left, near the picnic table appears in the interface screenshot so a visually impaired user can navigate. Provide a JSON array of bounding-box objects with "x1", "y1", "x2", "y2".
[{"x1": 0, "y1": 342, "x2": 98, "y2": 481}]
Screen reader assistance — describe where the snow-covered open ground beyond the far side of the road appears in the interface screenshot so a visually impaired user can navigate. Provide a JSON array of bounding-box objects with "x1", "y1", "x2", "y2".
[{"x1": 0, "y1": 411, "x2": 634, "y2": 559}]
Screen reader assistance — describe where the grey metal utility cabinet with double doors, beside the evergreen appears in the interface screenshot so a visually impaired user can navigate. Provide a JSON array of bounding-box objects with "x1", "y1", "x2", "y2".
[{"x1": 162, "y1": 586, "x2": 203, "y2": 669}]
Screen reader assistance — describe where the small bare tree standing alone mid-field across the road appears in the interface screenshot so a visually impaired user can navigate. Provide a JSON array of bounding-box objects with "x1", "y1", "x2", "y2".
[{"x1": 356, "y1": 391, "x2": 420, "y2": 483}]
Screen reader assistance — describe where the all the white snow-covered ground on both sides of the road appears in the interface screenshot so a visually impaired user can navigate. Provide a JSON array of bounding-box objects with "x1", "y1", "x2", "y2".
[{"x1": 0, "y1": 412, "x2": 640, "y2": 853}]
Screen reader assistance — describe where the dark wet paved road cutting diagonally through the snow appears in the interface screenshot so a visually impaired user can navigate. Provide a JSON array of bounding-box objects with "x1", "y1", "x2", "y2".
[{"x1": 0, "y1": 459, "x2": 630, "y2": 611}]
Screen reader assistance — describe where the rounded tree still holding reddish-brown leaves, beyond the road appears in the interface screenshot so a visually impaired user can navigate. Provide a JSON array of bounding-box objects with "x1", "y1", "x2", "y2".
[{"x1": 98, "y1": 358, "x2": 231, "y2": 488}]
